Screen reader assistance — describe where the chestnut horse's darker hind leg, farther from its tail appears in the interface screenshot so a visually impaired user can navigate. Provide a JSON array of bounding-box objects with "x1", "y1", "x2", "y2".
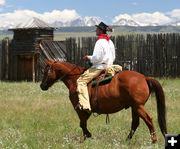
[{"x1": 127, "y1": 107, "x2": 139, "y2": 140}]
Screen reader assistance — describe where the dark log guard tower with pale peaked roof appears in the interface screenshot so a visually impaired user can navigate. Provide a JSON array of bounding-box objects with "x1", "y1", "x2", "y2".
[{"x1": 9, "y1": 18, "x2": 54, "y2": 82}]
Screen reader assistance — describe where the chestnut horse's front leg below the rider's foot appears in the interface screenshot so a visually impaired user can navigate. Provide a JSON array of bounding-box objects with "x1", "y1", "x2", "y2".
[{"x1": 77, "y1": 110, "x2": 91, "y2": 140}]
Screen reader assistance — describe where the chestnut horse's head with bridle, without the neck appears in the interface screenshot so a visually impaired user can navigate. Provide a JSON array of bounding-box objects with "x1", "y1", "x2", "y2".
[{"x1": 40, "y1": 60, "x2": 58, "y2": 91}]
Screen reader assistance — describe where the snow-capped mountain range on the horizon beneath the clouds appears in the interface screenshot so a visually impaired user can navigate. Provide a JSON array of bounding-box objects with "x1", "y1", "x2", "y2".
[{"x1": 0, "y1": 17, "x2": 180, "y2": 30}]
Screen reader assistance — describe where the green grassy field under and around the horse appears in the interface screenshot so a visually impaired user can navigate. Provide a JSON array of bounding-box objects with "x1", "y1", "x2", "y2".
[{"x1": 0, "y1": 79, "x2": 180, "y2": 149}]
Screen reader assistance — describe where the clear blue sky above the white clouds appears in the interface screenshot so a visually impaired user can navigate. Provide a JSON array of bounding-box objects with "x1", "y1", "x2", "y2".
[{"x1": 0, "y1": 0, "x2": 180, "y2": 20}]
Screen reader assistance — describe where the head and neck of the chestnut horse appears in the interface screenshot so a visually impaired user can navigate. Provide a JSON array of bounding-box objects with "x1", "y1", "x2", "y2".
[{"x1": 40, "y1": 60, "x2": 85, "y2": 90}]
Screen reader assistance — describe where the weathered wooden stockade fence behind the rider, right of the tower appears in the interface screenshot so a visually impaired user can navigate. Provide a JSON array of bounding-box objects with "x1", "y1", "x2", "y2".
[{"x1": 66, "y1": 33, "x2": 180, "y2": 77}]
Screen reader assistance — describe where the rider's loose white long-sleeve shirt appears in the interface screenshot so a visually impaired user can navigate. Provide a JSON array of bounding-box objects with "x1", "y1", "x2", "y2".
[{"x1": 88, "y1": 39, "x2": 115, "y2": 69}]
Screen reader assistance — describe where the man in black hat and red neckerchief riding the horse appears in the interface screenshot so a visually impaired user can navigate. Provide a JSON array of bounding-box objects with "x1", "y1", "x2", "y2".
[{"x1": 77, "y1": 22, "x2": 115, "y2": 112}]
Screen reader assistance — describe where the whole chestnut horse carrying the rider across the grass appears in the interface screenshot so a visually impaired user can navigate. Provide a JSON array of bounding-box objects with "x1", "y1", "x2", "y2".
[{"x1": 40, "y1": 60, "x2": 167, "y2": 143}]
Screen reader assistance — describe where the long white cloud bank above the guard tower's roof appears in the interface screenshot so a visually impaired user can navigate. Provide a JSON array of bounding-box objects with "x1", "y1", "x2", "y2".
[{"x1": 0, "y1": 9, "x2": 79, "y2": 28}]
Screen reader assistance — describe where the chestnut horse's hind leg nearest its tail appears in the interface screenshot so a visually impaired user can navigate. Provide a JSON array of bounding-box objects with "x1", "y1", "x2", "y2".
[{"x1": 137, "y1": 105, "x2": 157, "y2": 143}]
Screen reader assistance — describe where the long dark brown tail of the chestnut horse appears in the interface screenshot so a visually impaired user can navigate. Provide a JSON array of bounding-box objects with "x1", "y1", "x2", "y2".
[{"x1": 146, "y1": 77, "x2": 167, "y2": 136}]
